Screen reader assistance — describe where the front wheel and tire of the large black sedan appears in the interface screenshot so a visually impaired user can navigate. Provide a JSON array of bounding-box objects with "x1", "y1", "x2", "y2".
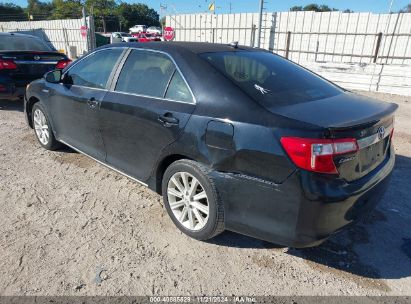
[{"x1": 31, "y1": 102, "x2": 61, "y2": 151}]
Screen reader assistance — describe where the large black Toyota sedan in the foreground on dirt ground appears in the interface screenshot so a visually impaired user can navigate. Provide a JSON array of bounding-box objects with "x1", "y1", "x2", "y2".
[{"x1": 25, "y1": 42, "x2": 397, "y2": 247}]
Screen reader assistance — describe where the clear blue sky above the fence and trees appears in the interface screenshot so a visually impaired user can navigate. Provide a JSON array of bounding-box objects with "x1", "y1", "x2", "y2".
[{"x1": 9, "y1": 0, "x2": 411, "y2": 14}]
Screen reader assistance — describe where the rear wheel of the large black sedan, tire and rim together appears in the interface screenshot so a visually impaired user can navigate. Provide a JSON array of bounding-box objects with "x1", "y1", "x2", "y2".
[{"x1": 162, "y1": 160, "x2": 224, "y2": 240}]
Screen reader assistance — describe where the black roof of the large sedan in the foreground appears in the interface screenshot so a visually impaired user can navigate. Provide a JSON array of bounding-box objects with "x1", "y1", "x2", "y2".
[{"x1": 100, "y1": 41, "x2": 264, "y2": 54}]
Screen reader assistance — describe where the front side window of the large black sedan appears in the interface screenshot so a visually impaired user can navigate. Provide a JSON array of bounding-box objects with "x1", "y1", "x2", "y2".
[{"x1": 64, "y1": 48, "x2": 123, "y2": 89}]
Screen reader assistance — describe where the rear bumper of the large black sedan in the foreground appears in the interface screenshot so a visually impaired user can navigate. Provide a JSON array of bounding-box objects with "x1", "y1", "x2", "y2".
[{"x1": 214, "y1": 148, "x2": 395, "y2": 247}]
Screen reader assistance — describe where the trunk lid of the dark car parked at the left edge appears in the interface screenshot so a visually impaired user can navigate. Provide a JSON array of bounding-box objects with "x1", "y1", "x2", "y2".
[{"x1": 0, "y1": 51, "x2": 67, "y2": 81}]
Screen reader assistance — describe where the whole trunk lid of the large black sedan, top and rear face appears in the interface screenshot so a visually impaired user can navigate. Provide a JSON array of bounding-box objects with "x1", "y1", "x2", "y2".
[{"x1": 268, "y1": 93, "x2": 398, "y2": 181}]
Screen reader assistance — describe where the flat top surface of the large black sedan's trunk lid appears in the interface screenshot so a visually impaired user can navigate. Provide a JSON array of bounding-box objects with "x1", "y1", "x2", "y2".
[{"x1": 267, "y1": 92, "x2": 398, "y2": 128}]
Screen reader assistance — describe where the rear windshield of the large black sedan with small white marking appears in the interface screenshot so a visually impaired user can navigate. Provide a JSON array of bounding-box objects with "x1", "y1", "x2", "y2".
[{"x1": 200, "y1": 51, "x2": 342, "y2": 108}]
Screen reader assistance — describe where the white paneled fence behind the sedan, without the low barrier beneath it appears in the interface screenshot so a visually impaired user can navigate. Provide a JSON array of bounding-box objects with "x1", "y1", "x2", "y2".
[{"x1": 166, "y1": 12, "x2": 411, "y2": 64}]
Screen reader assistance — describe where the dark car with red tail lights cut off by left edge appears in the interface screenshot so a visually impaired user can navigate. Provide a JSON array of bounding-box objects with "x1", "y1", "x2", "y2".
[{"x1": 0, "y1": 33, "x2": 71, "y2": 99}]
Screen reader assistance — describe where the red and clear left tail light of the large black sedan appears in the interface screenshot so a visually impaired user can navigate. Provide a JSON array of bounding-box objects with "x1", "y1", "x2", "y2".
[{"x1": 281, "y1": 137, "x2": 358, "y2": 174}]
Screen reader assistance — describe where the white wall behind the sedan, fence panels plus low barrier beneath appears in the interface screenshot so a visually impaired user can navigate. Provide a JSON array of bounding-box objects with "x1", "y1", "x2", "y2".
[{"x1": 166, "y1": 12, "x2": 411, "y2": 96}]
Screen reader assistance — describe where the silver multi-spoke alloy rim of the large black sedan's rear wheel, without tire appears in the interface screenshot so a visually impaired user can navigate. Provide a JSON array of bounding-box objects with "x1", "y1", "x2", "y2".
[{"x1": 167, "y1": 172, "x2": 210, "y2": 231}]
